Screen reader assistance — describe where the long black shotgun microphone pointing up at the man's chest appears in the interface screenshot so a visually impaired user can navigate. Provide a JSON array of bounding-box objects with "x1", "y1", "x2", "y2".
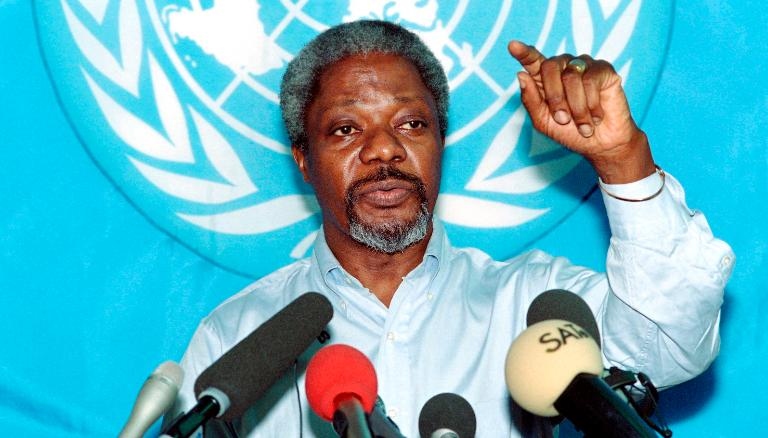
[{"x1": 163, "y1": 292, "x2": 333, "y2": 437}]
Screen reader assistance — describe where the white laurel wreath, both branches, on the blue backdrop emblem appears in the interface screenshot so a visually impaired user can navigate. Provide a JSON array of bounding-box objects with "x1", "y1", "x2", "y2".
[{"x1": 60, "y1": 0, "x2": 642, "y2": 258}]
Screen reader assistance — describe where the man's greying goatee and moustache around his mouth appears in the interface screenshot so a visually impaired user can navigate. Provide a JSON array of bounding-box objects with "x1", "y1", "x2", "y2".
[{"x1": 344, "y1": 166, "x2": 432, "y2": 254}]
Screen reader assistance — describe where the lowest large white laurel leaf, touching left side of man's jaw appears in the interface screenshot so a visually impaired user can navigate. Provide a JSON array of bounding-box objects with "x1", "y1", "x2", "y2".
[{"x1": 177, "y1": 195, "x2": 320, "y2": 235}]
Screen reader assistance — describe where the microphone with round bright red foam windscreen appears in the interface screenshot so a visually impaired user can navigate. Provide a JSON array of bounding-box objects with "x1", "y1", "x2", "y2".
[{"x1": 305, "y1": 344, "x2": 379, "y2": 438}]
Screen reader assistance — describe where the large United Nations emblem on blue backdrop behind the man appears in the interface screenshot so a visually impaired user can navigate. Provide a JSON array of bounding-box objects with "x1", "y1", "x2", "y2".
[{"x1": 35, "y1": 0, "x2": 671, "y2": 276}]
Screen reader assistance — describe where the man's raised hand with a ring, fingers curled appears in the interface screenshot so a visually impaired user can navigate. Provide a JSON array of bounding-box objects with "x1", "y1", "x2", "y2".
[{"x1": 507, "y1": 41, "x2": 655, "y2": 183}]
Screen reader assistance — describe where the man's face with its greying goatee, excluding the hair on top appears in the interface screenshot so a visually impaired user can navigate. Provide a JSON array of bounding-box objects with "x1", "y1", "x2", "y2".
[{"x1": 294, "y1": 54, "x2": 443, "y2": 253}]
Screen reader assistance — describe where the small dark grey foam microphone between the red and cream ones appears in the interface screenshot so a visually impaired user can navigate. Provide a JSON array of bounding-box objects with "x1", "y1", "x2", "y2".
[{"x1": 419, "y1": 392, "x2": 477, "y2": 438}]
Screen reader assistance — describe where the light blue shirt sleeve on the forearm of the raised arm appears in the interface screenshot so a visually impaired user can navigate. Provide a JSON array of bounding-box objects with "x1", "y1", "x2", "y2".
[{"x1": 598, "y1": 174, "x2": 734, "y2": 386}]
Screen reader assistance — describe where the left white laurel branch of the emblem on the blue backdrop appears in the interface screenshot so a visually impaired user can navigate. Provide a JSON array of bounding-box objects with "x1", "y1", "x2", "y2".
[{"x1": 61, "y1": 0, "x2": 319, "y2": 254}]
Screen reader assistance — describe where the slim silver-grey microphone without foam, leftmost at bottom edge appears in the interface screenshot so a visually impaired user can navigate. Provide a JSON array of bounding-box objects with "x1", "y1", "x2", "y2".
[{"x1": 118, "y1": 360, "x2": 184, "y2": 438}]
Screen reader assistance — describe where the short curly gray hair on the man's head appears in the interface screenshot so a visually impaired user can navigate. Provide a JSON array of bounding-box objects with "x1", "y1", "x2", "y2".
[{"x1": 280, "y1": 20, "x2": 449, "y2": 150}]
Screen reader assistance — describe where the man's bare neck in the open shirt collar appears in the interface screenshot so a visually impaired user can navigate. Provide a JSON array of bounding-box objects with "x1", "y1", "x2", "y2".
[{"x1": 325, "y1": 224, "x2": 432, "y2": 307}]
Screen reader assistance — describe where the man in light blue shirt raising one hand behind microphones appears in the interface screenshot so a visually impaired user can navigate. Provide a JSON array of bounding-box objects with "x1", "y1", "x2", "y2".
[{"x1": 166, "y1": 21, "x2": 733, "y2": 437}]
